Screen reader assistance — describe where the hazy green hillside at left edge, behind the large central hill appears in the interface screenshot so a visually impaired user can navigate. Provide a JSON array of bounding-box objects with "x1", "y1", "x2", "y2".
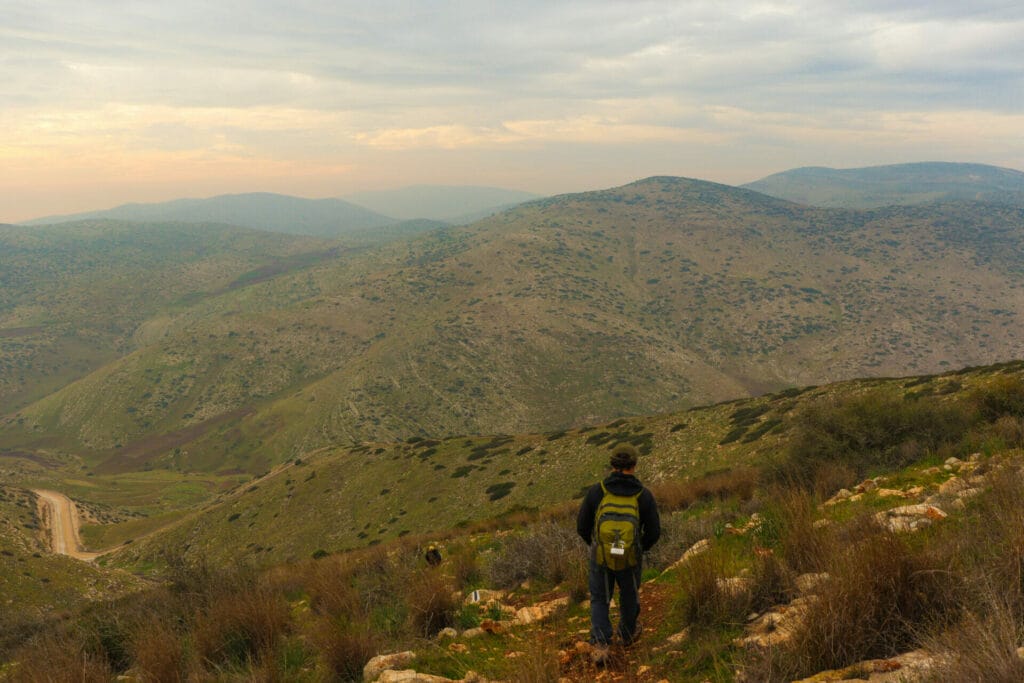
[{"x1": 0, "y1": 220, "x2": 340, "y2": 413}]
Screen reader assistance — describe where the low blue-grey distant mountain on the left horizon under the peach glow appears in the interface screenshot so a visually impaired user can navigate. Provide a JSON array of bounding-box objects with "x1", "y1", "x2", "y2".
[{"x1": 25, "y1": 193, "x2": 398, "y2": 238}]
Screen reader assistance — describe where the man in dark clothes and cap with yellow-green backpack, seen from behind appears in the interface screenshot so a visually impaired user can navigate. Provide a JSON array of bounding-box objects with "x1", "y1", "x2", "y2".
[{"x1": 577, "y1": 443, "x2": 662, "y2": 665}]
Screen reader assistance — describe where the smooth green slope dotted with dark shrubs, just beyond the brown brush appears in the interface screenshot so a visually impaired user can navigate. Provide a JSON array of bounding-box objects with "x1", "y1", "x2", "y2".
[{"x1": 108, "y1": 364, "x2": 1024, "y2": 564}]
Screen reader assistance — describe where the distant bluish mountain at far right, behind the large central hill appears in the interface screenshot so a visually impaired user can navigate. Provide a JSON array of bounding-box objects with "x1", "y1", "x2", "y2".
[{"x1": 743, "y1": 162, "x2": 1024, "y2": 209}]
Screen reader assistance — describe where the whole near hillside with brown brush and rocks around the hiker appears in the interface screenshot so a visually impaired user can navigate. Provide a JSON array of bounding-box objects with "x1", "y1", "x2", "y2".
[{"x1": 0, "y1": 361, "x2": 1024, "y2": 683}]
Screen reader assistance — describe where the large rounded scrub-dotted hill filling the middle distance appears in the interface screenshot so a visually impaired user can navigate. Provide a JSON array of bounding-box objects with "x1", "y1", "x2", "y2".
[{"x1": 0, "y1": 177, "x2": 1024, "y2": 473}]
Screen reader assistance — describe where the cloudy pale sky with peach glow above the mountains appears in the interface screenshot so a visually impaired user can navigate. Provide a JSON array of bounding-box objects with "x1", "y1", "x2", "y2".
[{"x1": 0, "y1": 0, "x2": 1024, "y2": 222}]
